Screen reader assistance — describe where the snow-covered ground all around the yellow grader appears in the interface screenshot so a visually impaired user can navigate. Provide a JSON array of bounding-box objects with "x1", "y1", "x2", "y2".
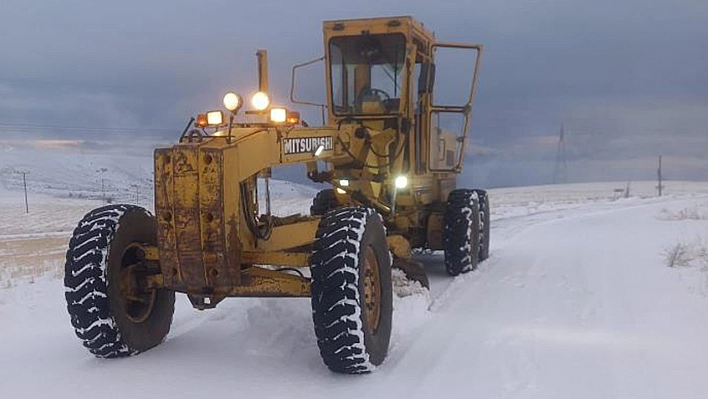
[{"x1": 0, "y1": 148, "x2": 708, "y2": 399}]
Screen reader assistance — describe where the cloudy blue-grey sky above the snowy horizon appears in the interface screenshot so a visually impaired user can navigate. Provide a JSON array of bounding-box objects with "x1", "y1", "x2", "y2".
[{"x1": 0, "y1": 0, "x2": 708, "y2": 186}]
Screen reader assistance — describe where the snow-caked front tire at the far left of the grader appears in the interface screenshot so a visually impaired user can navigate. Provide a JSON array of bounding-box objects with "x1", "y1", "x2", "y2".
[{"x1": 64, "y1": 205, "x2": 175, "y2": 358}]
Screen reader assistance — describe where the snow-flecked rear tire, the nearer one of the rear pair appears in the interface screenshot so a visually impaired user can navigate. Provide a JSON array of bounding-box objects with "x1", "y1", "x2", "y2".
[{"x1": 443, "y1": 189, "x2": 480, "y2": 276}]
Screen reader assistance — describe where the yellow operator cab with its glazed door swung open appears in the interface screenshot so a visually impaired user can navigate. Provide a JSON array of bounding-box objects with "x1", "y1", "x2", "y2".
[{"x1": 290, "y1": 16, "x2": 482, "y2": 175}]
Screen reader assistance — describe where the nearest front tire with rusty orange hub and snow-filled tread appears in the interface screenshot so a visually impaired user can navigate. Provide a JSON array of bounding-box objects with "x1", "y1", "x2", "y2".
[{"x1": 310, "y1": 207, "x2": 393, "y2": 374}]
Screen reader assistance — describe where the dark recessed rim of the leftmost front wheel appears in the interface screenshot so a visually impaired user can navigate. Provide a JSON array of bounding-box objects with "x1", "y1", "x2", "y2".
[{"x1": 120, "y1": 243, "x2": 157, "y2": 323}]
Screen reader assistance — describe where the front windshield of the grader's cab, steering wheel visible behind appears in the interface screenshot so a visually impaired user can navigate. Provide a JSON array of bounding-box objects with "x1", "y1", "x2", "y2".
[{"x1": 329, "y1": 34, "x2": 405, "y2": 115}]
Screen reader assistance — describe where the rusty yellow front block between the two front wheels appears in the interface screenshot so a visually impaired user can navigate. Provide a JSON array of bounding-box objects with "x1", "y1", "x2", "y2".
[{"x1": 155, "y1": 145, "x2": 240, "y2": 292}]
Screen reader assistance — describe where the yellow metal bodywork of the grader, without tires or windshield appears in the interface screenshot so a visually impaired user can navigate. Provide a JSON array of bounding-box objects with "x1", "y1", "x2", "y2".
[{"x1": 146, "y1": 17, "x2": 481, "y2": 302}]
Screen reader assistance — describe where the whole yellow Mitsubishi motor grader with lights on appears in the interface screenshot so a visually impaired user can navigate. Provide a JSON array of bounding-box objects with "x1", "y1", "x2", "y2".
[{"x1": 64, "y1": 17, "x2": 489, "y2": 373}]
